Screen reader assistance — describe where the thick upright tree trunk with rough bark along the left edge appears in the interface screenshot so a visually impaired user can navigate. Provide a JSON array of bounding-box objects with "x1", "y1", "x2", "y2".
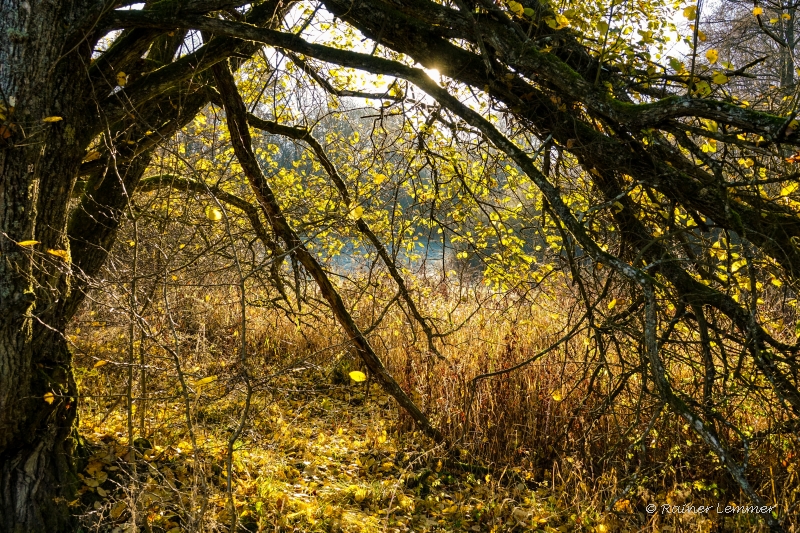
[{"x1": 0, "y1": 0, "x2": 102, "y2": 533}]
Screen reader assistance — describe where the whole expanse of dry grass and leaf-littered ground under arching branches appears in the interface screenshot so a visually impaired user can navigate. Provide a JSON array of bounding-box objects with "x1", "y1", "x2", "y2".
[{"x1": 71, "y1": 276, "x2": 800, "y2": 532}]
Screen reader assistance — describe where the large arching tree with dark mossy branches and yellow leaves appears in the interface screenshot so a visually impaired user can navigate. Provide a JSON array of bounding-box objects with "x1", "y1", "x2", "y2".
[{"x1": 0, "y1": 0, "x2": 800, "y2": 533}]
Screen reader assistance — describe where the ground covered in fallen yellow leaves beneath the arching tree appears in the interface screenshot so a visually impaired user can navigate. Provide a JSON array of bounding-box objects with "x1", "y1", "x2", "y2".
[{"x1": 73, "y1": 370, "x2": 624, "y2": 533}]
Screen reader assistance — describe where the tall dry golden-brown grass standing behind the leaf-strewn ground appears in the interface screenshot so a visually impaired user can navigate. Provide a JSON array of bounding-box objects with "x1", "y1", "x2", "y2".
[{"x1": 70, "y1": 268, "x2": 800, "y2": 531}]
